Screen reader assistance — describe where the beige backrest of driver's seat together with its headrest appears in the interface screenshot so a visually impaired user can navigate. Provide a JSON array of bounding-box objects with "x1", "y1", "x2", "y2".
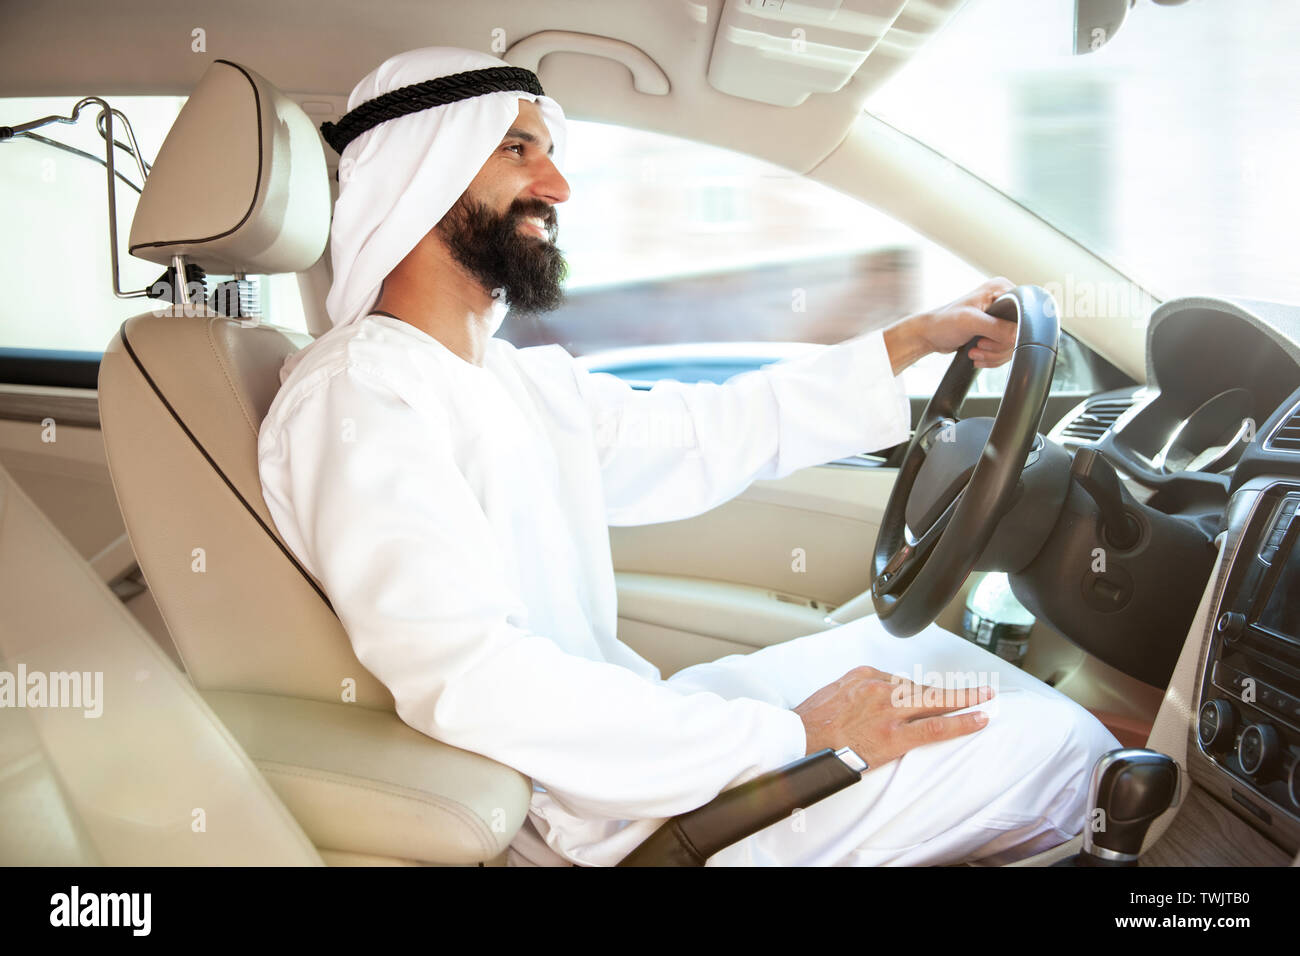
[{"x1": 99, "y1": 60, "x2": 393, "y2": 709}]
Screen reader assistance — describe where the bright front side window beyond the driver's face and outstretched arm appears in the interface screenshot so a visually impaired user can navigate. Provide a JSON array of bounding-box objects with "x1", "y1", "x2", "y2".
[{"x1": 499, "y1": 121, "x2": 1086, "y2": 395}]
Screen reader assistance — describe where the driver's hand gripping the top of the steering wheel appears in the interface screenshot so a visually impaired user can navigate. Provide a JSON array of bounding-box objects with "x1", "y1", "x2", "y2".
[{"x1": 884, "y1": 276, "x2": 1015, "y2": 375}]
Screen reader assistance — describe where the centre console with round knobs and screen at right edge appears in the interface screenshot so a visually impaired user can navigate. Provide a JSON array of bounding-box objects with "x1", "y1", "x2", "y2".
[{"x1": 1188, "y1": 481, "x2": 1300, "y2": 853}]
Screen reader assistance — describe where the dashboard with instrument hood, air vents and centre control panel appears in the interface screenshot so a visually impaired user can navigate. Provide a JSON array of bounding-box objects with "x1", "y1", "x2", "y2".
[{"x1": 1049, "y1": 298, "x2": 1300, "y2": 853}]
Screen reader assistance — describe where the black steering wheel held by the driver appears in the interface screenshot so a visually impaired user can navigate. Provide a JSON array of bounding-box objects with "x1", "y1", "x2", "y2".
[{"x1": 871, "y1": 286, "x2": 1060, "y2": 637}]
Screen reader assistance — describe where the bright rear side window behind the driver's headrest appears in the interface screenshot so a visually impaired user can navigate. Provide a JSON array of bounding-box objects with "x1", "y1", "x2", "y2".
[{"x1": 0, "y1": 96, "x2": 306, "y2": 352}]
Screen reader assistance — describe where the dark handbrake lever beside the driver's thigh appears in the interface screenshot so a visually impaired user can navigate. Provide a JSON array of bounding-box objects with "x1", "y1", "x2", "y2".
[{"x1": 619, "y1": 749, "x2": 861, "y2": 866}]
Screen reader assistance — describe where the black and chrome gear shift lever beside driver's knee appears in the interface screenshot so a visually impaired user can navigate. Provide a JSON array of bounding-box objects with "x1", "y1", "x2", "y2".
[{"x1": 1075, "y1": 749, "x2": 1179, "y2": 866}]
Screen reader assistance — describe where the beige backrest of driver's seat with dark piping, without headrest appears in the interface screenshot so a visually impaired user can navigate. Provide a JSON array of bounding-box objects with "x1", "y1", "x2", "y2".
[{"x1": 99, "y1": 313, "x2": 393, "y2": 709}]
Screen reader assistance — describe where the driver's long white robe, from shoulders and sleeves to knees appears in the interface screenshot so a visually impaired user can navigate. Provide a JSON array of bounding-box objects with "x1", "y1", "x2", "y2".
[{"x1": 259, "y1": 315, "x2": 1117, "y2": 865}]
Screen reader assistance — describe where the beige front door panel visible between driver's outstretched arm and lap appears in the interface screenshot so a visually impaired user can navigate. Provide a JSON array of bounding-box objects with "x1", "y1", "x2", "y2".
[{"x1": 610, "y1": 466, "x2": 897, "y2": 675}]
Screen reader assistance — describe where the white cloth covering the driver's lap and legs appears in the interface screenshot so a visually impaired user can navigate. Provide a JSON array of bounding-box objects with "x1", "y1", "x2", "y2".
[{"x1": 670, "y1": 615, "x2": 1119, "y2": 866}]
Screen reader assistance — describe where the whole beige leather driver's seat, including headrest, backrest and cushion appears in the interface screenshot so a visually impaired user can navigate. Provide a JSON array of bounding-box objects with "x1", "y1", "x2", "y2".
[{"x1": 99, "y1": 60, "x2": 532, "y2": 864}]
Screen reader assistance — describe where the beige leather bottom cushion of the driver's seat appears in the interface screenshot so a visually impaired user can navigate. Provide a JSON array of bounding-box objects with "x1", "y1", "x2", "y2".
[{"x1": 203, "y1": 691, "x2": 533, "y2": 864}]
